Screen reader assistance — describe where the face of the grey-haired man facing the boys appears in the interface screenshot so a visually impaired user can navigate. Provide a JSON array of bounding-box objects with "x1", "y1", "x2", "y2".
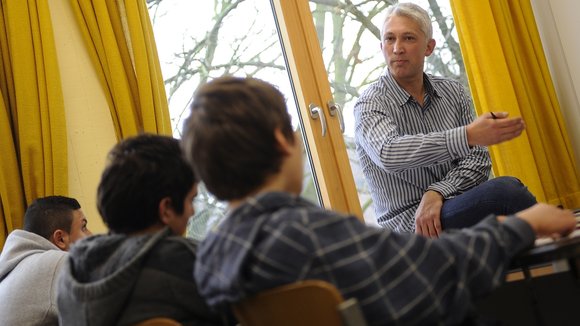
[{"x1": 381, "y1": 16, "x2": 435, "y2": 84}]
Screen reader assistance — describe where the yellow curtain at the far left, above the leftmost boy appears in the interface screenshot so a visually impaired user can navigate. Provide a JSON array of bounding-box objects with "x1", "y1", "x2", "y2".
[{"x1": 0, "y1": 0, "x2": 68, "y2": 250}]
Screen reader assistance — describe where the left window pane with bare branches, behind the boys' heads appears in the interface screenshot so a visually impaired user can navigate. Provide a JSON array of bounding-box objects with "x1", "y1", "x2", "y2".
[{"x1": 147, "y1": 0, "x2": 319, "y2": 239}]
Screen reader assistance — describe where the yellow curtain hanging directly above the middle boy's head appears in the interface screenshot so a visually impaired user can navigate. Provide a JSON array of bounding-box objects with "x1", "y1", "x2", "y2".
[{"x1": 70, "y1": 0, "x2": 171, "y2": 139}]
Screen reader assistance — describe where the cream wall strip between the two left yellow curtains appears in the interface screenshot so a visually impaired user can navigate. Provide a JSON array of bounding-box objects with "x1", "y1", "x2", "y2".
[{"x1": 49, "y1": 0, "x2": 117, "y2": 233}]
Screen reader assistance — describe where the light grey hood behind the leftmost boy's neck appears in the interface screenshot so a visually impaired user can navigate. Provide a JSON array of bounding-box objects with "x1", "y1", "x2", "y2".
[{"x1": 0, "y1": 230, "x2": 61, "y2": 281}]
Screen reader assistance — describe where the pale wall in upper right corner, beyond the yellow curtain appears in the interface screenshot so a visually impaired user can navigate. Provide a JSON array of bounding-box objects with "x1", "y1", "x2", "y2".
[{"x1": 532, "y1": 0, "x2": 580, "y2": 167}]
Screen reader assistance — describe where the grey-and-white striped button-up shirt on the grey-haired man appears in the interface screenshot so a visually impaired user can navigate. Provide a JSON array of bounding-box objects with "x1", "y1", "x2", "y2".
[{"x1": 354, "y1": 69, "x2": 491, "y2": 232}]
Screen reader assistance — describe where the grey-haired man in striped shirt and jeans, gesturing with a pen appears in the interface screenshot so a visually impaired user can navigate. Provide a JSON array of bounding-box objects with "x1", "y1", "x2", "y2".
[{"x1": 354, "y1": 3, "x2": 536, "y2": 237}]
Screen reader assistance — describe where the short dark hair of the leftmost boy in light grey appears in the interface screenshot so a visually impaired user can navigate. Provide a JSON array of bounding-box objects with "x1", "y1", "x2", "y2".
[{"x1": 24, "y1": 196, "x2": 81, "y2": 240}]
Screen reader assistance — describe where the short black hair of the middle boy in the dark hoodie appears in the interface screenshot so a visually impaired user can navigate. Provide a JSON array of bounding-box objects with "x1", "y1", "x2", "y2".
[{"x1": 97, "y1": 133, "x2": 197, "y2": 233}]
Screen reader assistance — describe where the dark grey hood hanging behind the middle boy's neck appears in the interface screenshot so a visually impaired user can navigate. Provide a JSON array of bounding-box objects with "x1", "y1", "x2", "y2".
[{"x1": 58, "y1": 228, "x2": 171, "y2": 325}]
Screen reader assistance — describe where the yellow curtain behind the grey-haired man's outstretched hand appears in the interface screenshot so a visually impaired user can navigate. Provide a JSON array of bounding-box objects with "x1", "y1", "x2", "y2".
[{"x1": 451, "y1": 0, "x2": 580, "y2": 208}]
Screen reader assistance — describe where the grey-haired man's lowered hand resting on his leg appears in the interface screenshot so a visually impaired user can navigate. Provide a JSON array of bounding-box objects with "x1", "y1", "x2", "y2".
[{"x1": 415, "y1": 190, "x2": 443, "y2": 238}]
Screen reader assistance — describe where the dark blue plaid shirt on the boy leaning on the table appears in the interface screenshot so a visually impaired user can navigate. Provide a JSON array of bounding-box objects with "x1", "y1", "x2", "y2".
[{"x1": 194, "y1": 192, "x2": 534, "y2": 325}]
